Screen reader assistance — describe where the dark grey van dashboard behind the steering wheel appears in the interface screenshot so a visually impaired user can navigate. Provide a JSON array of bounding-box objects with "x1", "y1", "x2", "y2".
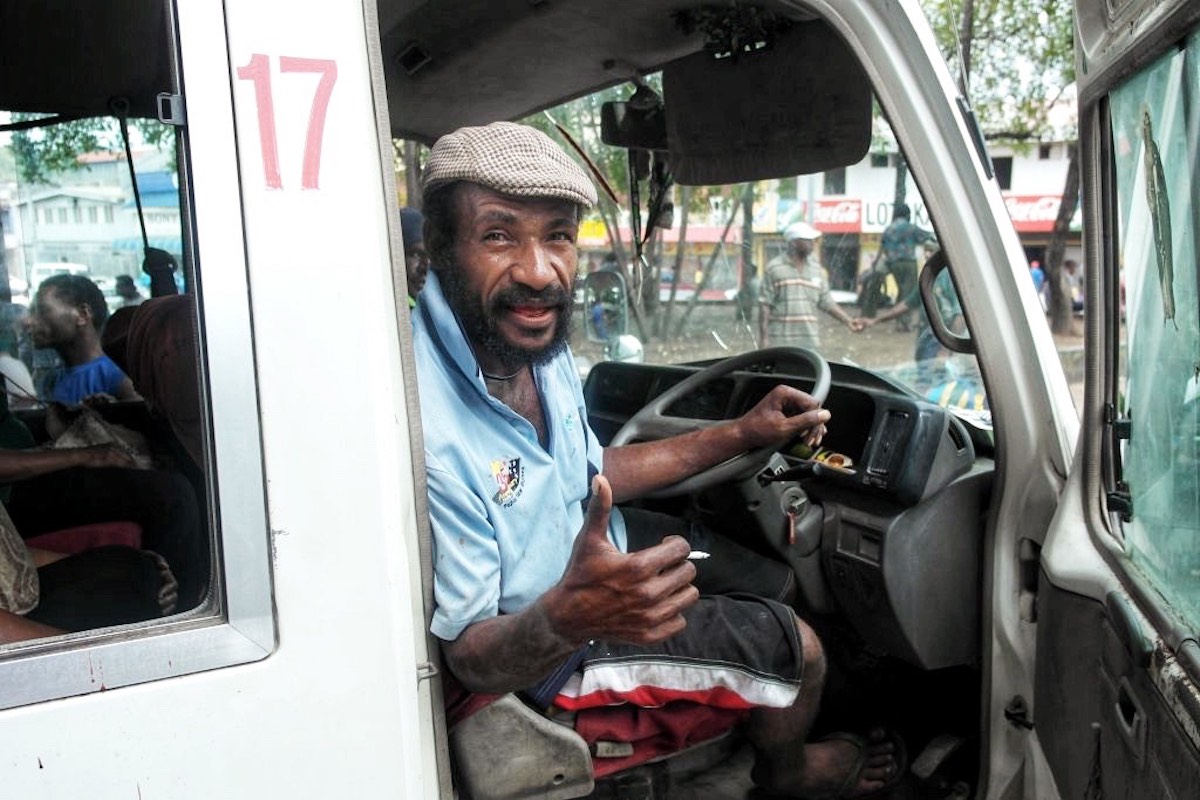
[{"x1": 584, "y1": 359, "x2": 995, "y2": 669}]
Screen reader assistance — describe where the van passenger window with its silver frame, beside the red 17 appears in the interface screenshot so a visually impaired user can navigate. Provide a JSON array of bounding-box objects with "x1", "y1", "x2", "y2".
[{"x1": 0, "y1": 2, "x2": 275, "y2": 708}]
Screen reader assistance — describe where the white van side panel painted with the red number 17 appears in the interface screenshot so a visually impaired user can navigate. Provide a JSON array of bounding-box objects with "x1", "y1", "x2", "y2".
[{"x1": 0, "y1": 2, "x2": 448, "y2": 799}]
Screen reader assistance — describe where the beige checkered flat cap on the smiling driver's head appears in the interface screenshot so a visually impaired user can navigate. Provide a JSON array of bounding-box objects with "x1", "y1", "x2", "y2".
[{"x1": 421, "y1": 122, "x2": 596, "y2": 207}]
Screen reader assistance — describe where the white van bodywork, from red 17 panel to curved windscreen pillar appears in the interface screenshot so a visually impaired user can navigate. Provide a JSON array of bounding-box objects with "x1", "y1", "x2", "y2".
[{"x1": 0, "y1": 0, "x2": 1200, "y2": 800}]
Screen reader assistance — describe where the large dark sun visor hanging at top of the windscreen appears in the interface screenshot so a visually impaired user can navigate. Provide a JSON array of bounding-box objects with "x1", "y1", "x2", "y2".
[{"x1": 662, "y1": 22, "x2": 871, "y2": 186}]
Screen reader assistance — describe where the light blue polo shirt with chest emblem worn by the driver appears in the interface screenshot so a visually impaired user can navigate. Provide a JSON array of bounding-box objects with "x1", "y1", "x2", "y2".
[{"x1": 413, "y1": 272, "x2": 625, "y2": 640}]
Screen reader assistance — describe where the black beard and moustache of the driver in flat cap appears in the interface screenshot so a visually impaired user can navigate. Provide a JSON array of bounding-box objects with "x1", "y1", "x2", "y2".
[{"x1": 438, "y1": 264, "x2": 575, "y2": 366}]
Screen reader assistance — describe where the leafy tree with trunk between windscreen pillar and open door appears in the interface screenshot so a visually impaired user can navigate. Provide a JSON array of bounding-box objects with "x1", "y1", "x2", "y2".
[{"x1": 922, "y1": 0, "x2": 1079, "y2": 333}]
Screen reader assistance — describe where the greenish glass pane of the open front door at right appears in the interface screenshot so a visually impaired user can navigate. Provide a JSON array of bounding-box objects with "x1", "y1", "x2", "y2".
[{"x1": 1111, "y1": 36, "x2": 1200, "y2": 624}]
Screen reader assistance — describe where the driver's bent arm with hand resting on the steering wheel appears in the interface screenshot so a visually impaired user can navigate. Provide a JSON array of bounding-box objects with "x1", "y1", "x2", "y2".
[{"x1": 604, "y1": 385, "x2": 829, "y2": 503}]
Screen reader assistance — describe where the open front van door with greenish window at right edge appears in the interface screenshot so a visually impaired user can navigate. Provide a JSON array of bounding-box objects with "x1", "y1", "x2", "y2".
[{"x1": 1032, "y1": 0, "x2": 1200, "y2": 800}]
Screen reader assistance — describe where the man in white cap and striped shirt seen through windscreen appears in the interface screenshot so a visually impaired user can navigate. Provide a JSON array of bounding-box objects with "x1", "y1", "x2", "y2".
[{"x1": 758, "y1": 222, "x2": 863, "y2": 350}]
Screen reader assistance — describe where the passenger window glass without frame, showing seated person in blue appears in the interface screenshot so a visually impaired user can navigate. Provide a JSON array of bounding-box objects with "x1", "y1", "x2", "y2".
[{"x1": 0, "y1": 118, "x2": 211, "y2": 644}]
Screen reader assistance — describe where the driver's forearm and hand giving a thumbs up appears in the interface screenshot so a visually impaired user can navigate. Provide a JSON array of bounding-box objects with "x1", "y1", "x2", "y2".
[{"x1": 442, "y1": 476, "x2": 700, "y2": 693}]
